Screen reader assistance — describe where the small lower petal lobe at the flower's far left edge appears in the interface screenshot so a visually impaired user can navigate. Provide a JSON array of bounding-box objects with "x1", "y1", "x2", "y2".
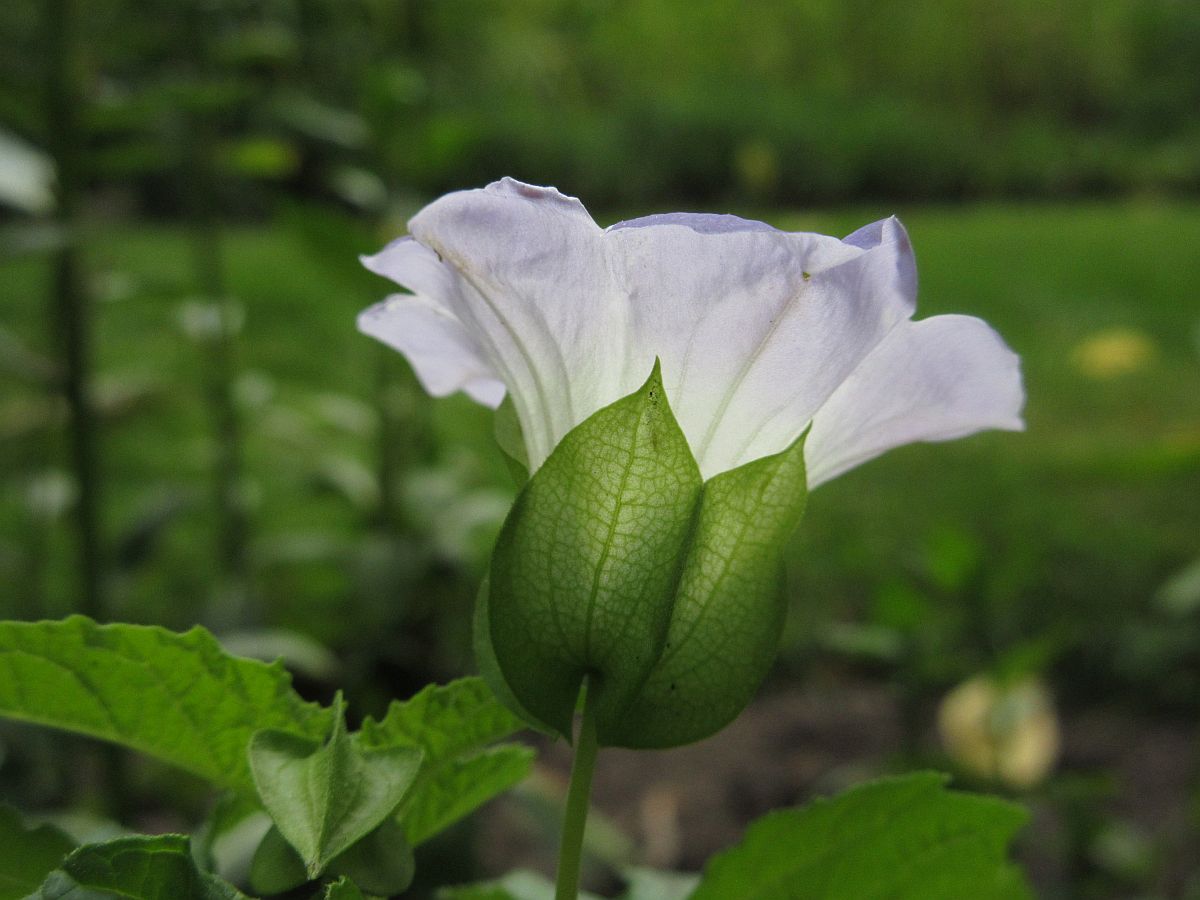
[{"x1": 359, "y1": 294, "x2": 504, "y2": 409}]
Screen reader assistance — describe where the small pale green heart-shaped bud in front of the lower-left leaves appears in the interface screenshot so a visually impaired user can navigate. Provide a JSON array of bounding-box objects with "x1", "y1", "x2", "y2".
[{"x1": 250, "y1": 695, "x2": 421, "y2": 878}]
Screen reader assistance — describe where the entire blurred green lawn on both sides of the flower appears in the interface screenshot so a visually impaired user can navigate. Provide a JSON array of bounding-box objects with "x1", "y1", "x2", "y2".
[{"x1": 0, "y1": 200, "x2": 1200, "y2": 710}]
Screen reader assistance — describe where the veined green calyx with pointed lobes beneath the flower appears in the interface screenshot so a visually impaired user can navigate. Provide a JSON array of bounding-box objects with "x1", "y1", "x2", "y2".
[{"x1": 475, "y1": 364, "x2": 806, "y2": 748}]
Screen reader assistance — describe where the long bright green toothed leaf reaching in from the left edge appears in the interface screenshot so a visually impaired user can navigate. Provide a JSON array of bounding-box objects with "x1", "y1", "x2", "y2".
[{"x1": 0, "y1": 616, "x2": 330, "y2": 792}]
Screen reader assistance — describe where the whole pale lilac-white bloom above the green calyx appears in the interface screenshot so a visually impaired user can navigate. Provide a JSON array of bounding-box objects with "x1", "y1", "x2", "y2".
[{"x1": 359, "y1": 179, "x2": 1025, "y2": 487}]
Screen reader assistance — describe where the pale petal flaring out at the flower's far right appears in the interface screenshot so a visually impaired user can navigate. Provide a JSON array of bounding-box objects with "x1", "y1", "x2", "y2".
[{"x1": 805, "y1": 316, "x2": 1025, "y2": 487}]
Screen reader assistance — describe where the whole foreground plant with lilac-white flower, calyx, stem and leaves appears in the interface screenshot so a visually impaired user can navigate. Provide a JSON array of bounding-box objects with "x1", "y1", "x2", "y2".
[{"x1": 0, "y1": 179, "x2": 1030, "y2": 900}]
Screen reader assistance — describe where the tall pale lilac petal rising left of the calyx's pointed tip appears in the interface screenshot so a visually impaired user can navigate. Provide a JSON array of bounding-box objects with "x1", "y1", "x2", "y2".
[{"x1": 409, "y1": 179, "x2": 624, "y2": 468}]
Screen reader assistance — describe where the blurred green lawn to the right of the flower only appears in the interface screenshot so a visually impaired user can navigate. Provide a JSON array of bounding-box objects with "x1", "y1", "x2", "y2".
[{"x1": 768, "y1": 203, "x2": 1200, "y2": 690}]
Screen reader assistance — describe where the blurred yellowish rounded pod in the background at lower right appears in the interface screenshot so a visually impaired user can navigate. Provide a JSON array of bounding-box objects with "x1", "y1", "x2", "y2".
[{"x1": 937, "y1": 676, "x2": 1061, "y2": 790}]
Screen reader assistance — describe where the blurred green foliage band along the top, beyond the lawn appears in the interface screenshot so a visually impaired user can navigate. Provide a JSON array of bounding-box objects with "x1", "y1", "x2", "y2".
[{"x1": 0, "y1": 0, "x2": 1200, "y2": 206}]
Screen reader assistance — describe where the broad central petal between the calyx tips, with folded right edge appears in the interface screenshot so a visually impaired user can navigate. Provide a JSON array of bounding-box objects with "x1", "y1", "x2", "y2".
[{"x1": 607, "y1": 214, "x2": 916, "y2": 478}]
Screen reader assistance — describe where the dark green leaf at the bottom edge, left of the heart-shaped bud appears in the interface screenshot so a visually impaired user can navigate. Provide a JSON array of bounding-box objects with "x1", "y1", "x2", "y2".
[{"x1": 29, "y1": 834, "x2": 246, "y2": 900}]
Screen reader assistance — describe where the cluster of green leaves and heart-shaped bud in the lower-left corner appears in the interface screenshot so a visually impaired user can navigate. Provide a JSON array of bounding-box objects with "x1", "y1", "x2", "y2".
[{"x1": 0, "y1": 617, "x2": 532, "y2": 900}]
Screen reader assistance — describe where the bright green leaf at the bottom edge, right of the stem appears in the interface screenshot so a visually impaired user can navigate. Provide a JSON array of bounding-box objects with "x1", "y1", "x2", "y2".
[{"x1": 691, "y1": 772, "x2": 1031, "y2": 900}]
